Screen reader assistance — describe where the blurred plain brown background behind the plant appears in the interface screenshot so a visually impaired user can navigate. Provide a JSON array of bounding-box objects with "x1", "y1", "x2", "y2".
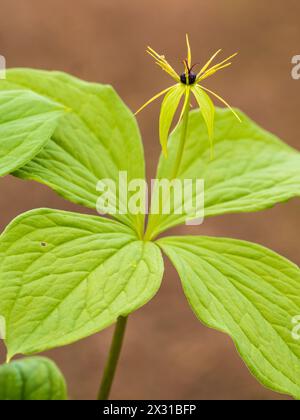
[{"x1": 0, "y1": 0, "x2": 300, "y2": 399}]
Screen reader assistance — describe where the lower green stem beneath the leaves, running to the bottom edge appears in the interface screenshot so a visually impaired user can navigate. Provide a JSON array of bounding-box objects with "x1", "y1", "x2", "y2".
[{"x1": 98, "y1": 316, "x2": 127, "y2": 401}]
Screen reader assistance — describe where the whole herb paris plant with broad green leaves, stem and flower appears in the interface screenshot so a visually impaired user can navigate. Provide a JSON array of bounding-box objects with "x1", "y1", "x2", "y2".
[{"x1": 0, "y1": 37, "x2": 300, "y2": 398}]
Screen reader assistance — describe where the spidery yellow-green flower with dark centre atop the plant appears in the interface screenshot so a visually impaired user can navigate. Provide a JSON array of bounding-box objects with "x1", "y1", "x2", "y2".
[{"x1": 136, "y1": 35, "x2": 240, "y2": 156}]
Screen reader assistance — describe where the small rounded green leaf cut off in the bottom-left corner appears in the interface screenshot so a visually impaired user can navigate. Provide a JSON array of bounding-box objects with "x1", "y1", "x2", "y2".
[{"x1": 0, "y1": 357, "x2": 67, "y2": 401}]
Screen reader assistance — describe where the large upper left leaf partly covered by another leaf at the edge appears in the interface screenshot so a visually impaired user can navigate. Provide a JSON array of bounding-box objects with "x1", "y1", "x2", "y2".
[{"x1": 0, "y1": 69, "x2": 145, "y2": 232}]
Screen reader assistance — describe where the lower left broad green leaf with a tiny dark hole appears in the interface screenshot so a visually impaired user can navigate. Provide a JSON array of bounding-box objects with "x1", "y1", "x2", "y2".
[{"x1": 0, "y1": 209, "x2": 163, "y2": 358}]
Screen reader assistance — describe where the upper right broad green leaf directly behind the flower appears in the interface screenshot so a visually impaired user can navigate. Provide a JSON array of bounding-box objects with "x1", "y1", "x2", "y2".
[{"x1": 148, "y1": 108, "x2": 300, "y2": 237}]
